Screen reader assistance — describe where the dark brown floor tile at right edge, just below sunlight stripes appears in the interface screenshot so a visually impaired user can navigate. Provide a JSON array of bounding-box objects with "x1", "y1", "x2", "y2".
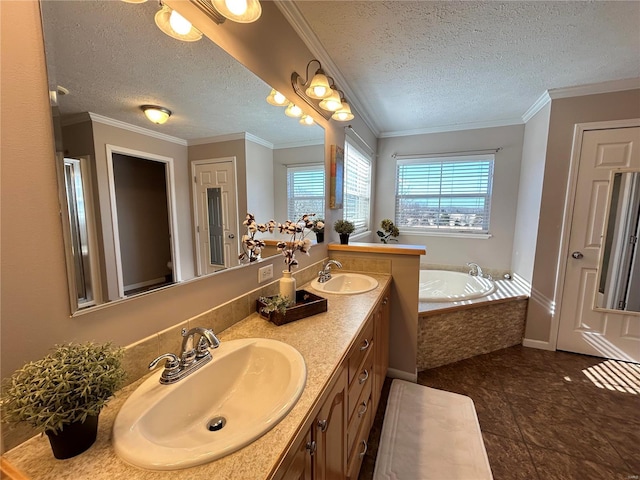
[{"x1": 568, "y1": 382, "x2": 640, "y2": 420}]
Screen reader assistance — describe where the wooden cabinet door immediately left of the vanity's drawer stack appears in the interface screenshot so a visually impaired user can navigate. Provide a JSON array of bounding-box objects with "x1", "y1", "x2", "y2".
[{"x1": 313, "y1": 368, "x2": 347, "y2": 480}]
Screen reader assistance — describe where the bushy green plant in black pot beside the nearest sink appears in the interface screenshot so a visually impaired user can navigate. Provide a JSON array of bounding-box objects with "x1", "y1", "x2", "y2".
[{"x1": 2, "y1": 342, "x2": 125, "y2": 459}]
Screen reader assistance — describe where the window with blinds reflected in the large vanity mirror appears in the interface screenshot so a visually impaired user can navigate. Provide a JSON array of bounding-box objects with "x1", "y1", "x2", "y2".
[{"x1": 287, "y1": 163, "x2": 324, "y2": 222}]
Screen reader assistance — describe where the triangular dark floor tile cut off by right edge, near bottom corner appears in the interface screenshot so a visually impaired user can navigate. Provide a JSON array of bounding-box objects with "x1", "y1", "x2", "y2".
[{"x1": 589, "y1": 414, "x2": 640, "y2": 476}]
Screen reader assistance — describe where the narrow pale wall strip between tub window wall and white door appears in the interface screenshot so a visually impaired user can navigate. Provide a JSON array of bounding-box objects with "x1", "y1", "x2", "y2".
[{"x1": 511, "y1": 103, "x2": 551, "y2": 284}]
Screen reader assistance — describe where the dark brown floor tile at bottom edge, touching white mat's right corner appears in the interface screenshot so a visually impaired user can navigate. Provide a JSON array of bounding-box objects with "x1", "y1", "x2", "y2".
[{"x1": 482, "y1": 432, "x2": 546, "y2": 480}]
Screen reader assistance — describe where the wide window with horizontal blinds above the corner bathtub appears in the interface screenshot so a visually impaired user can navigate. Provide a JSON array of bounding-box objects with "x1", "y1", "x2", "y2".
[{"x1": 396, "y1": 155, "x2": 494, "y2": 233}]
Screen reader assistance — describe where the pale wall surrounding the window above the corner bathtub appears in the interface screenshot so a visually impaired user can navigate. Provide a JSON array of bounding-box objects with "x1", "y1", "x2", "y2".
[{"x1": 372, "y1": 125, "x2": 524, "y2": 270}]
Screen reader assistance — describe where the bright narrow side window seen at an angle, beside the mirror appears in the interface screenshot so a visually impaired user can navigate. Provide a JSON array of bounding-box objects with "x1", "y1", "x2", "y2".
[{"x1": 342, "y1": 137, "x2": 373, "y2": 236}]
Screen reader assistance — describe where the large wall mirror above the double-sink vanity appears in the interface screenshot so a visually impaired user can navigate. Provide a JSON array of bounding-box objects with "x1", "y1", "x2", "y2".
[{"x1": 41, "y1": 0, "x2": 325, "y2": 313}]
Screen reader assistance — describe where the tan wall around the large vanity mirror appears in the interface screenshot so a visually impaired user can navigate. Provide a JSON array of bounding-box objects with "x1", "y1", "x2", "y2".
[{"x1": 0, "y1": 1, "x2": 384, "y2": 386}]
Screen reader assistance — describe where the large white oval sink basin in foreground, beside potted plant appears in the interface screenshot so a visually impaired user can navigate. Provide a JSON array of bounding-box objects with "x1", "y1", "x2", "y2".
[{"x1": 113, "y1": 338, "x2": 307, "y2": 470}]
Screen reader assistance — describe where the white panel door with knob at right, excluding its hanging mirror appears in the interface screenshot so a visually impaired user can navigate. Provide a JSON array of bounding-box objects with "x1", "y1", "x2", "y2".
[{"x1": 557, "y1": 128, "x2": 640, "y2": 362}]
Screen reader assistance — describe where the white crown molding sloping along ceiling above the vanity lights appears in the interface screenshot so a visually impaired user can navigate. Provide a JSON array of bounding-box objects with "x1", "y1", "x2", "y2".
[{"x1": 274, "y1": 0, "x2": 380, "y2": 137}]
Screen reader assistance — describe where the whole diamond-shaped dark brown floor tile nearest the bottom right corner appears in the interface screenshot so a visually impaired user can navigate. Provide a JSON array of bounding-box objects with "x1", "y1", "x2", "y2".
[{"x1": 510, "y1": 396, "x2": 626, "y2": 468}]
